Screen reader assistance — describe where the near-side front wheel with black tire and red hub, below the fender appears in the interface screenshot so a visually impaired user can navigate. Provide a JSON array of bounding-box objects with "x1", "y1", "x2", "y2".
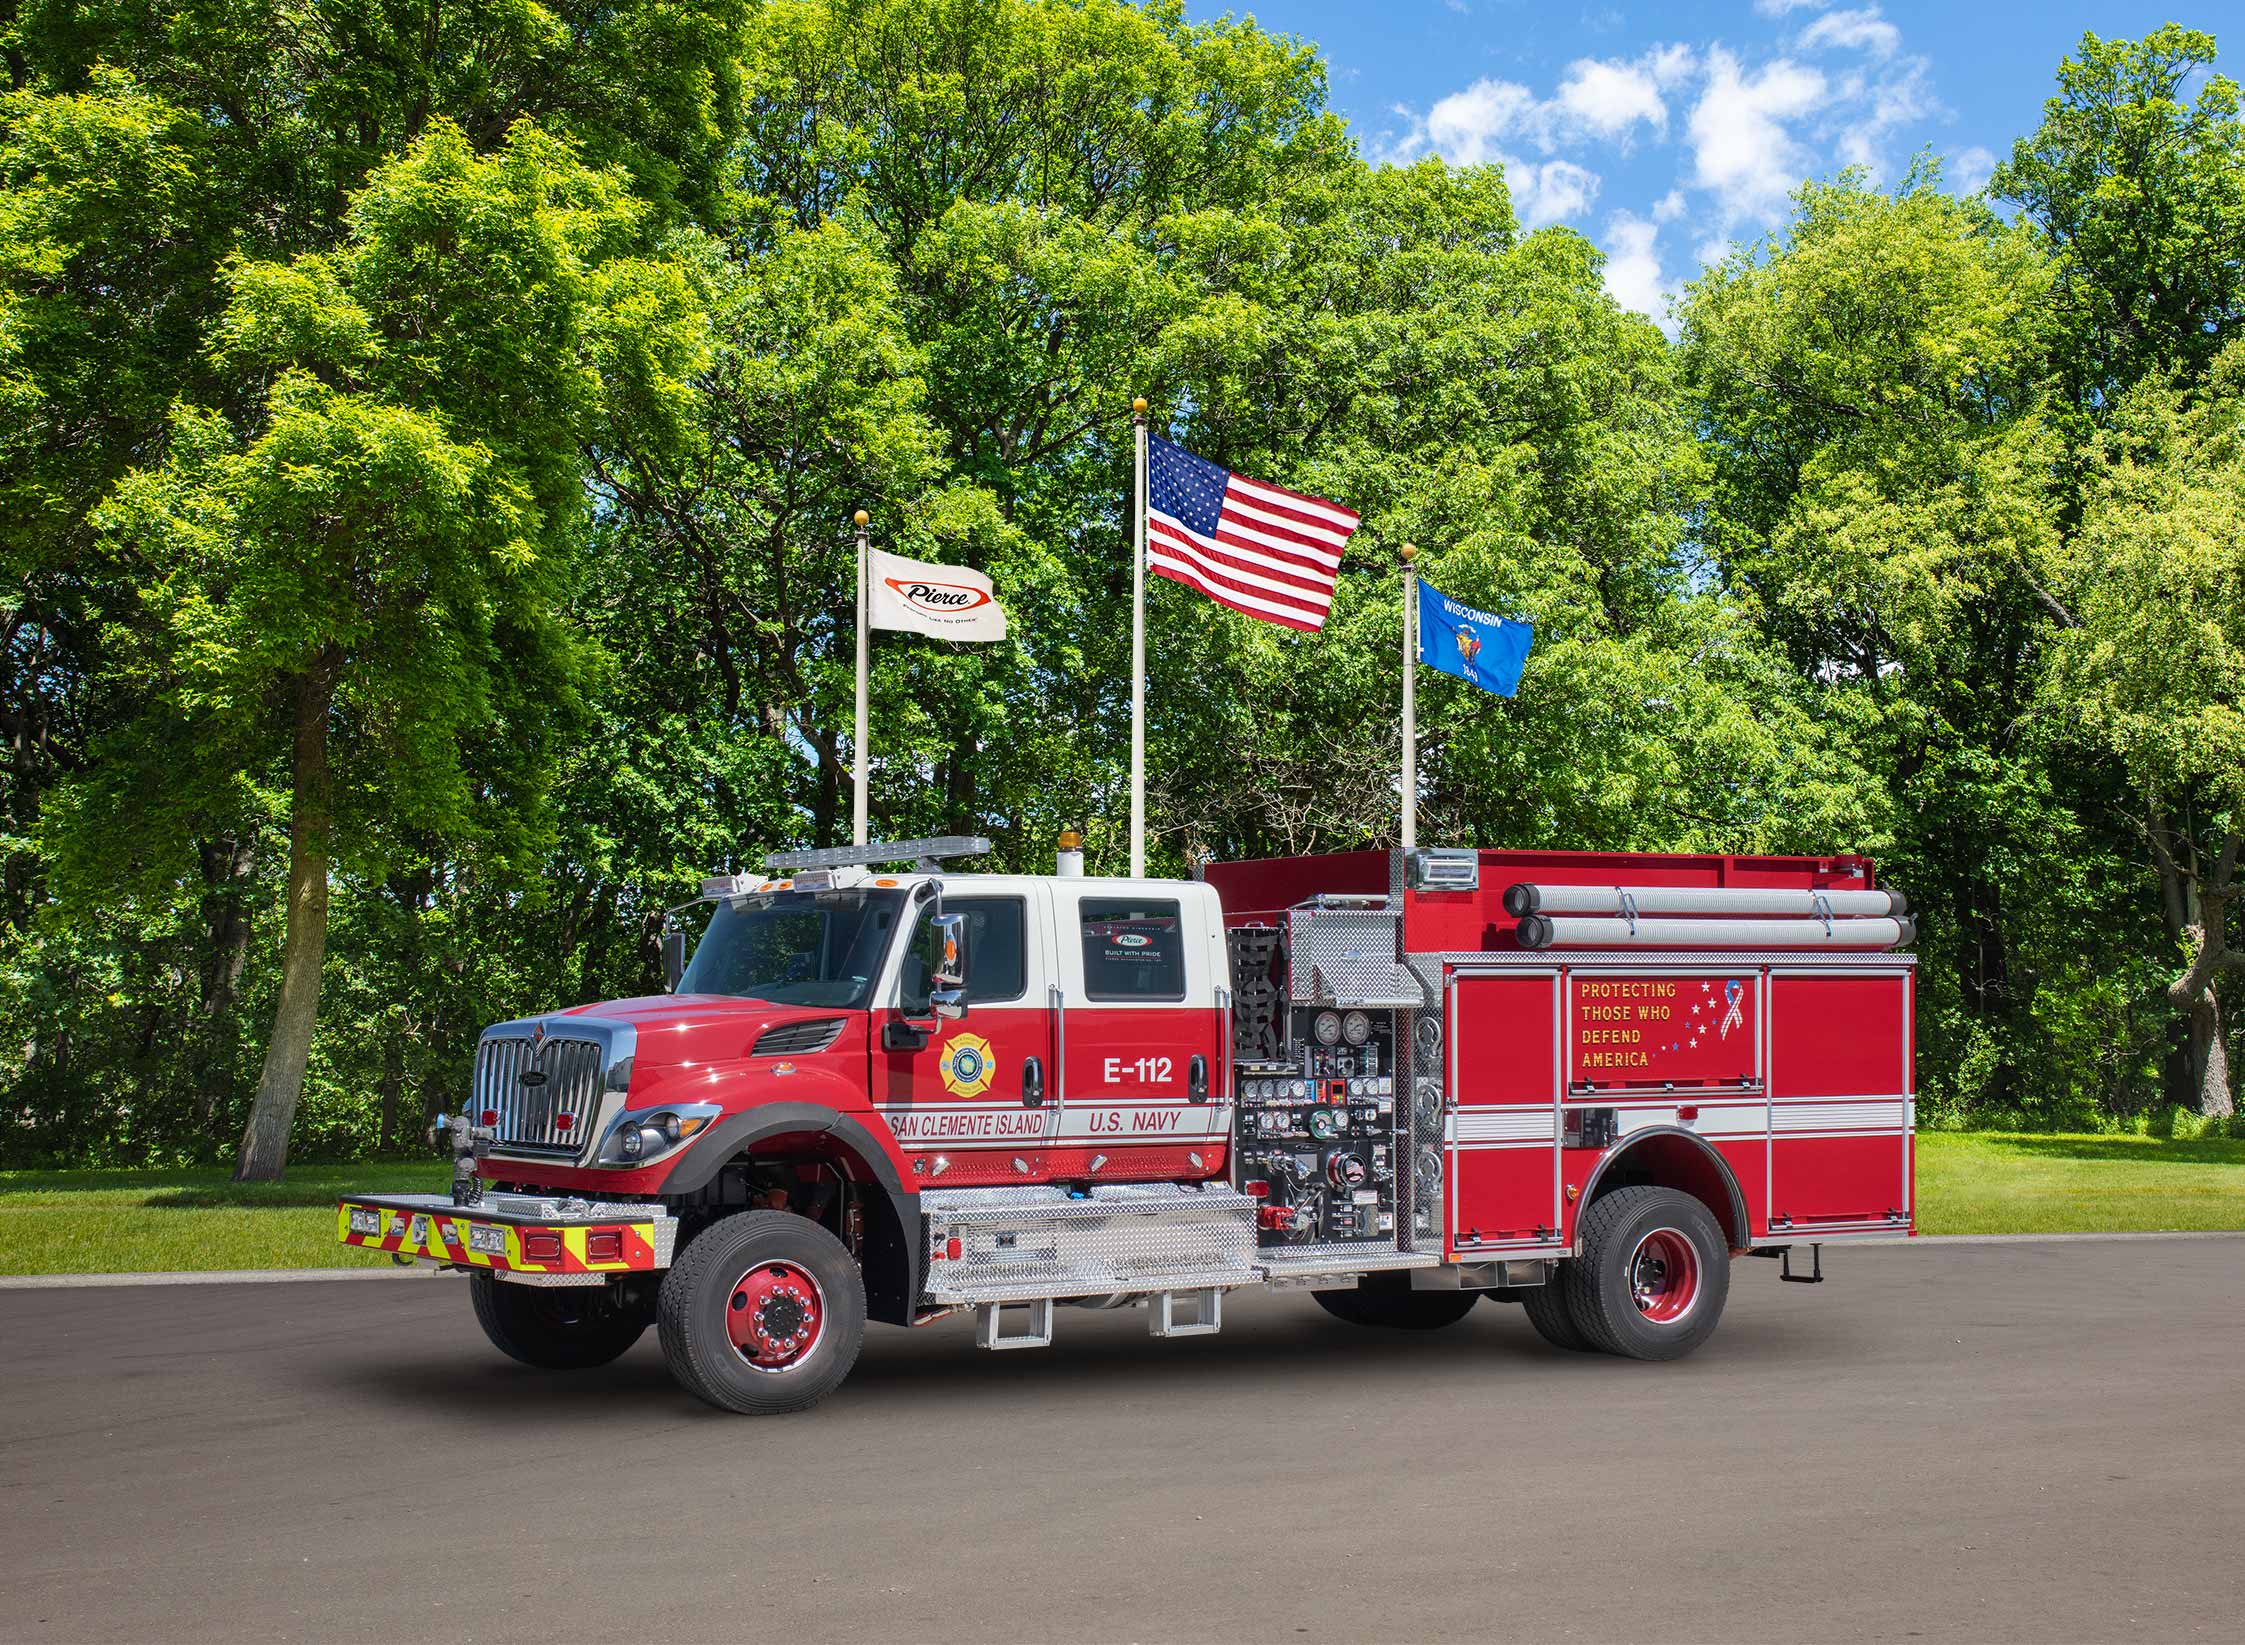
[{"x1": 656, "y1": 1212, "x2": 864, "y2": 1416}]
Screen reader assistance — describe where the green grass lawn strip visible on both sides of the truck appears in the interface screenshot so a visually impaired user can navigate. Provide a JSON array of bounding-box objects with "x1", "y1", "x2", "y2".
[{"x1": 0, "y1": 1131, "x2": 2245, "y2": 1275}]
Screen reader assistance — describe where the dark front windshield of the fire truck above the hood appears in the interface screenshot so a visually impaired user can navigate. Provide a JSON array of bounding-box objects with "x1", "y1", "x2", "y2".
[{"x1": 678, "y1": 891, "x2": 905, "y2": 1010}]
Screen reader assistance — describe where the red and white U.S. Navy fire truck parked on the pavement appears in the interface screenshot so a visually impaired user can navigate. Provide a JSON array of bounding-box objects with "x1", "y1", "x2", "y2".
[{"x1": 337, "y1": 839, "x2": 1915, "y2": 1412}]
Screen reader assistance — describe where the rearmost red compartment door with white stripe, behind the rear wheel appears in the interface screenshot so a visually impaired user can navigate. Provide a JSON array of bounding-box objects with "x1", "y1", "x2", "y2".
[{"x1": 1769, "y1": 967, "x2": 1913, "y2": 1232}]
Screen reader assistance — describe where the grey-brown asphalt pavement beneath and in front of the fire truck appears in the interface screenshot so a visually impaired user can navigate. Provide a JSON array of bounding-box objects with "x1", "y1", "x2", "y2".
[{"x1": 0, "y1": 1239, "x2": 2245, "y2": 1645}]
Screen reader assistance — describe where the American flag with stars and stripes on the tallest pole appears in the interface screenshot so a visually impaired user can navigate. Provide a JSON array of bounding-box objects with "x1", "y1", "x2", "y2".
[{"x1": 1145, "y1": 438, "x2": 1356, "y2": 633}]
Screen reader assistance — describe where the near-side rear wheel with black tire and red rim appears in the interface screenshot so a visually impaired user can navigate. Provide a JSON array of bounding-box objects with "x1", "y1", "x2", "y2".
[{"x1": 1560, "y1": 1187, "x2": 1731, "y2": 1360}]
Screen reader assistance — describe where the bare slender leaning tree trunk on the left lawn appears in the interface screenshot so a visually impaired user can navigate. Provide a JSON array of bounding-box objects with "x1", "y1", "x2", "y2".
[{"x1": 233, "y1": 653, "x2": 335, "y2": 1183}]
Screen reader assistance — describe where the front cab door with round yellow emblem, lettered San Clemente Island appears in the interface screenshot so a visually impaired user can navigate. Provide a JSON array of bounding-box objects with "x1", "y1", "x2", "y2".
[{"x1": 871, "y1": 886, "x2": 1055, "y2": 1187}]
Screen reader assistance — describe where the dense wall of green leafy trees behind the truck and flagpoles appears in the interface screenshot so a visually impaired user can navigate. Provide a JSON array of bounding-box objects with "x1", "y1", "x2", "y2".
[{"x1": 0, "y1": 0, "x2": 2245, "y2": 1160}]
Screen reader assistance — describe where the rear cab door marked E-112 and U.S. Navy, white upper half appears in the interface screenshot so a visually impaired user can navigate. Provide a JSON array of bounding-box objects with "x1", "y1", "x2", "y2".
[{"x1": 1051, "y1": 880, "x2": 1230, "y2": 1183}]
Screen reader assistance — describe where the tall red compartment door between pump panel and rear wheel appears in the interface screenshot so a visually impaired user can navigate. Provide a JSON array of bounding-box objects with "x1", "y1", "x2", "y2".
[{"x1": 1444, "y1": 969, "x2": 1563, "y2": 1257}]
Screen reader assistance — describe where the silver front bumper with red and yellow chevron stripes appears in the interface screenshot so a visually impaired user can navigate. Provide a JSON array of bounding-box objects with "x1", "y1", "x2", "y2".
[{"x1": 335, "y1": 1194, "x2": 678, "y2": 1286}]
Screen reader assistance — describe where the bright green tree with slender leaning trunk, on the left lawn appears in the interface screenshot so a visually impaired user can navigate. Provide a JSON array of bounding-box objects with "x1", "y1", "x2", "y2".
[{"x1": 67, "y1": 121, "x2": 698, "y2": 1178}]
